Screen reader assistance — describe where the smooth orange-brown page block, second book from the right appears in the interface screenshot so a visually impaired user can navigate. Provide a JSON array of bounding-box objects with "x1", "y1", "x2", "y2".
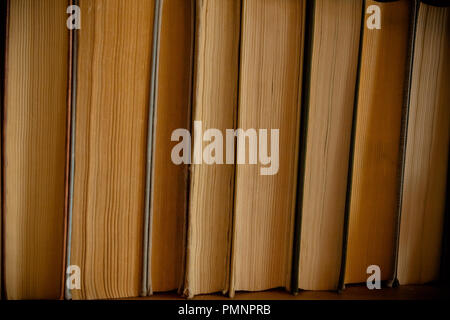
[{"x1": 344, "y1": 0, "x2": 412, "y2": 283}]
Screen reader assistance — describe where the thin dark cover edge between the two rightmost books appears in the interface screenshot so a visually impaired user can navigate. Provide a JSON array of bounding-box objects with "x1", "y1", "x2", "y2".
[{"x1": 387, "y1": 0, "x2": 419, "y2": 287}]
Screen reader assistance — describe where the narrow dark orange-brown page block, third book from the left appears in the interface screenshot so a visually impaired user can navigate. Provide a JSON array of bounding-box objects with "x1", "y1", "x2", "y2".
[{"x1": 149, "y1": 0, "x2": 194, "y2": 293}]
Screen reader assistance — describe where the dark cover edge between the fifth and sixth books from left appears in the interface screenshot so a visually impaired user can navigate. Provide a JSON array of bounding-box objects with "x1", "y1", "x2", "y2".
[{"x1": 291, "y1": 0, "x2": 316, "y2": 295}]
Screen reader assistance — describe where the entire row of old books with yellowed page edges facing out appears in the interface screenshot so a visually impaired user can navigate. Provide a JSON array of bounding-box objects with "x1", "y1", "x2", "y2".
[{"x1": 0, "y1": 0, "x2": 450, "y2": 299}]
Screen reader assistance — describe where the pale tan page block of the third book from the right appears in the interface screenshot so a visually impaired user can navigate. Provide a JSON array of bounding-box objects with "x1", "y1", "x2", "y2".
[{"x1": 294, "y1": 0, "x2": 362, "y2": 290}]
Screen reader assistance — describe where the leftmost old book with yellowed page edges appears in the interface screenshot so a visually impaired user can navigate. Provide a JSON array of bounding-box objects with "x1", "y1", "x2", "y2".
[{"x1": 2, "y1": 0, "x2": 69, "y2": 299}]
